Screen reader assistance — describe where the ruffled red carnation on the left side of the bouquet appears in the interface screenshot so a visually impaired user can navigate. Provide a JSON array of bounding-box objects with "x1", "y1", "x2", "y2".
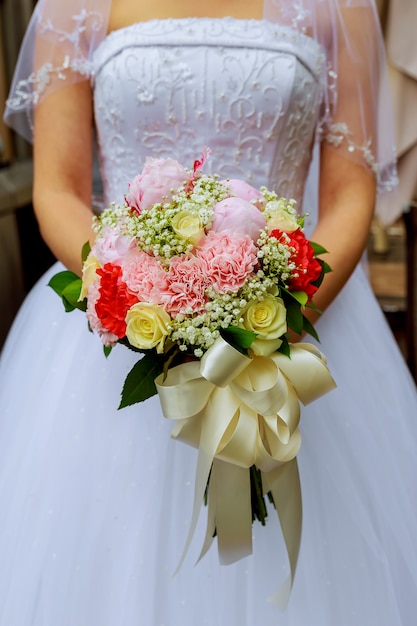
[{"x1": 96, "y1": 263, "x2": 138, "y2": 339}]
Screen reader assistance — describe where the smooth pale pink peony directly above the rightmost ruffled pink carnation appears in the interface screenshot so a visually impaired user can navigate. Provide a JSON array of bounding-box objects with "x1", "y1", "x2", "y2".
[{"x1": 211, "y1": 197, "x2": 266, "y2": 241}]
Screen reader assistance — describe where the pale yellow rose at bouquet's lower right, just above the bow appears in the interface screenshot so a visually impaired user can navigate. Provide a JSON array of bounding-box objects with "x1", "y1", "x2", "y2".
[{"x1": 243, "y1": 295, "x2": 287, "y2": 355}]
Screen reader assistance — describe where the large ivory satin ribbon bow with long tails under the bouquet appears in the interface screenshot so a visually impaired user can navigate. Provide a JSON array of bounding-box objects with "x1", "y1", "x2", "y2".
[{"x1": 155, "y1": 337, "x2": 335, "y2": 608}]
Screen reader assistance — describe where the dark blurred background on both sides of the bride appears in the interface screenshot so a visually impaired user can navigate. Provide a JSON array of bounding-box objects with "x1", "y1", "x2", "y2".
[{"x1": 0, "y1": 0, "x2": 417, "y2": 380}]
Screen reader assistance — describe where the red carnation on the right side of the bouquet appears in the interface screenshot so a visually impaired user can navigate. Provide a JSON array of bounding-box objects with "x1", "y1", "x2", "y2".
[{"x1": 271, "y1": 228, "x2": 322, "y2": 302}]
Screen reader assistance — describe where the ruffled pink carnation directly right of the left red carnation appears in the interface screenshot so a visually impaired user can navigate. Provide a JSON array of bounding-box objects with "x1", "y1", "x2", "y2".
[{"x1": 123, "y1": 247, "x2": 167, "y2": 303}]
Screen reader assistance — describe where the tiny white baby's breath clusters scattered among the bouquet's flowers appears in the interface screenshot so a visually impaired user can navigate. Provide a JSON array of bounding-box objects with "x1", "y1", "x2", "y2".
[{"x1": 94, "y1": 175, "x2": 302, "y2": 358}]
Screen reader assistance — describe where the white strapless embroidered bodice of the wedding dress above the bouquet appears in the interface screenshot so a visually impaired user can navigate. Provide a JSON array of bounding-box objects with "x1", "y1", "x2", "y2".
[{"x1": 93, "y1": 18, "x2": 323, "y2": 206}]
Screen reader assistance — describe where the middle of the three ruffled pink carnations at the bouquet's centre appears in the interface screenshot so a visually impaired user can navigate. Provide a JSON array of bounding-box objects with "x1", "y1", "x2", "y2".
[{"x1": 158, "y1": 255, "x2": 211, "y2": 315}]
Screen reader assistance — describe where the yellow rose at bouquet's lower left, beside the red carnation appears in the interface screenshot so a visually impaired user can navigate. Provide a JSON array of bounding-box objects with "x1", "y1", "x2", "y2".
[{"x1": 126, "y1": 302, "x2": 171, "y2": 354}]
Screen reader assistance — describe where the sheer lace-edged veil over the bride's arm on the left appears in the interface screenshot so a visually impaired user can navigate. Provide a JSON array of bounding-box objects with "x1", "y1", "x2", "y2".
[{"x1": 4, "y1": 0, "x2": 111, "y2": 142}]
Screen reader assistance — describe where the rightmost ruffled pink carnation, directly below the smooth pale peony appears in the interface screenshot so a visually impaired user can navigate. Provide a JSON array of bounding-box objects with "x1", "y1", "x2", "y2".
[{"x1": 198, "y1": 232, "x2": 258, "y2": 293}]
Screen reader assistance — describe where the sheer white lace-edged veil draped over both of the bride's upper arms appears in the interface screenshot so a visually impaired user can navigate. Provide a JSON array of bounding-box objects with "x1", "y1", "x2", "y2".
[{"x1": 4, "y1": 0, "x2": 397, "y2": 222}]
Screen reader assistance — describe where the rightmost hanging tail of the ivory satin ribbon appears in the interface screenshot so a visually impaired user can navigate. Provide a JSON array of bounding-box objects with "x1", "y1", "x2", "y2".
[{"x1": 262, "y1": 458, "x2": 302, "y2": 610}]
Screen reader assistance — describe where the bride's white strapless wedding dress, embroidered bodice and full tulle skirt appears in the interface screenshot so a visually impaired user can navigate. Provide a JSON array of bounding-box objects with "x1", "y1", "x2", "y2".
[{"x1": 0, "y1": 18, "x2": 417, "y2": 626}]
